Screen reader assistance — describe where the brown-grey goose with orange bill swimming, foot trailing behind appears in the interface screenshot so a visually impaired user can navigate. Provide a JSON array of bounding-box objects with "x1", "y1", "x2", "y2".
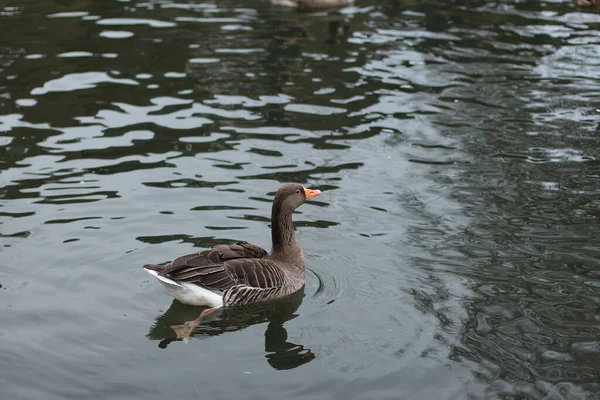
[{"x1": 144, "y1": 184, "x2": 321, "y2": 339}]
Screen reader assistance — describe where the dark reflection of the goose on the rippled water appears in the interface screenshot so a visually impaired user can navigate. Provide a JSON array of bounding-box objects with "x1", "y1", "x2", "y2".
[{"x1": 147, "y1": 289, "x2": 315, "y2": 370}]
